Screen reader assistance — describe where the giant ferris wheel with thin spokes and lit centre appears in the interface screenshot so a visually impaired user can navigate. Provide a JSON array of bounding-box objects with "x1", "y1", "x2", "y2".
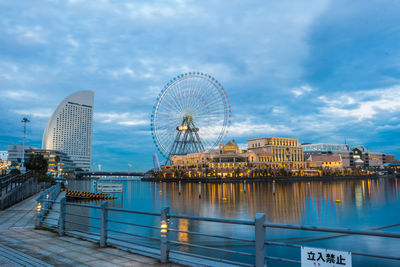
[{"x1": 151, "y1": 72, "x2": 231, "y2": 160}]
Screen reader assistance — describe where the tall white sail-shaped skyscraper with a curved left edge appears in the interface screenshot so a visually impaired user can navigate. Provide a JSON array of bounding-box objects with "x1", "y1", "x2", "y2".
[{"x1": 42, "y1": 91, "x2": 94, "y2": 171}]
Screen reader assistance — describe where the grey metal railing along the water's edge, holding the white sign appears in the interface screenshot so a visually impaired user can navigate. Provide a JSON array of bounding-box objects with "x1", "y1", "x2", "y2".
[{"x1": 34, "y1": 201, "x2": 400, "y2": 266}]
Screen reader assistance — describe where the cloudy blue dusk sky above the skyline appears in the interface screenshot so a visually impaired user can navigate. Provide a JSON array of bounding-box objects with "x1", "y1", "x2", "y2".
[{"x1": 0, "y1": 0, "x2": 400, "y2": 170}]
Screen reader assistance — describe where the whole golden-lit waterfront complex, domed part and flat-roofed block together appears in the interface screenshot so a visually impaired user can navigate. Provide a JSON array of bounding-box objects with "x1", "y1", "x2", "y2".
[{"x1": 166, "y1": 137, "x2": 305, "y2": 177}]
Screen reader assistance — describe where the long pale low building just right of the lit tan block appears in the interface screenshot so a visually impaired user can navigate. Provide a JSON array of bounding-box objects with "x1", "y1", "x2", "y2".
[{"x1": 301, "y1": 143, "x2": 354, "y2": 168}]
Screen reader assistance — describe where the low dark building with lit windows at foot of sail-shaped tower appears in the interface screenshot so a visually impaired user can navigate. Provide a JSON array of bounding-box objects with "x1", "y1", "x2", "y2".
[{"x1": 26, "y1": 149, "x2": 75, "y2": 174}]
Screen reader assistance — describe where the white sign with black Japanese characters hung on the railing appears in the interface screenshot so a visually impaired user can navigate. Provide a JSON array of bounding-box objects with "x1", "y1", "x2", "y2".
[{"x1": 301, "y1": 247, "x2": 351, "y2": 267}]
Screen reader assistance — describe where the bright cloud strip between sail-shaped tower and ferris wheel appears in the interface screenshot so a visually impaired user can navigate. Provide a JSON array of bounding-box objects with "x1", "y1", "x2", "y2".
[{"x1": 94, "y1": 112, "x2": 149, "y2": 126}]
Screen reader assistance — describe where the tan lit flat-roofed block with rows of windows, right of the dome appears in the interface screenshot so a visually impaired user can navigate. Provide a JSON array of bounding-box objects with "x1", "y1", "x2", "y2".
[{"x1": 247, "y1": 137, "x2": 306, "y2": 169}]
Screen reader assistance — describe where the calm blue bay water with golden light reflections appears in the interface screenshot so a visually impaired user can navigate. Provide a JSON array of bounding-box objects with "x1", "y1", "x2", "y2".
[{"x1": 69, "y1": 178, "x2": 400, "y2": 266}]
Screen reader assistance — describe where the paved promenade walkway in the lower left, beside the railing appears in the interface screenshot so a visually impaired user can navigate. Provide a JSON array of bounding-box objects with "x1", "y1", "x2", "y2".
[{"x1": 0, "y1": 195, "x2": 180, "y2": 267}]
